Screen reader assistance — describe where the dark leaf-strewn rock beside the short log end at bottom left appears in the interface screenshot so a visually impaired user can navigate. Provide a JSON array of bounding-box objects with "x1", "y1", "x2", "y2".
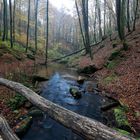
[{"x1": 15, "y1": 116, "x2": 32, "y2": 136}]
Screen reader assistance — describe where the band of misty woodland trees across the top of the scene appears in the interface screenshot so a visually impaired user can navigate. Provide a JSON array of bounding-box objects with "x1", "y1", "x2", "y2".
[{"x1": 0, "y1": 0, "x2": 140, "y2": 59}]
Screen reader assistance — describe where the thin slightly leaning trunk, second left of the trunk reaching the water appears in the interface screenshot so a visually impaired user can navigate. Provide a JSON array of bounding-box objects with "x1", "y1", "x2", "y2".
[{"x1": 26, "y1": 0, "x2": 31, "y2": 52}]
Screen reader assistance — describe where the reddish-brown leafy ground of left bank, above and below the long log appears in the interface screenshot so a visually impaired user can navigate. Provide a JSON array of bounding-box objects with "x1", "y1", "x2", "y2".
[{"x1": 0, "y1": 43, "x2": 34, "y2": 127}]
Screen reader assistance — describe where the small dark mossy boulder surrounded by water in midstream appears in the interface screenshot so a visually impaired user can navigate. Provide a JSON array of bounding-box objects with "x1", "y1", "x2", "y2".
[{"x1": 69, "y1": 87, "x2": 82, "y2": 99}]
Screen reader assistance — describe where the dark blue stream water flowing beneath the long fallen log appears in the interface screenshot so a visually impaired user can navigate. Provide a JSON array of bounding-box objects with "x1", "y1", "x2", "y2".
[{"x1": 22, "y1": 64, "x2": 113, "y2": 140}]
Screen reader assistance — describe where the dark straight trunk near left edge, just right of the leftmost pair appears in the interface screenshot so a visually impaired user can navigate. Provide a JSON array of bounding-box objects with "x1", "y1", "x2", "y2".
[{"x1": 9, "y1": 0, "x2": 13, "y2": 48}]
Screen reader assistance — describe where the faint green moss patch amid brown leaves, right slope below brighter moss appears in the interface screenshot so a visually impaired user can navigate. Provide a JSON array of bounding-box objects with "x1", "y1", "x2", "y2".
[{"x1": 103, "y1": 73, "x2": 118, "y2": 85}]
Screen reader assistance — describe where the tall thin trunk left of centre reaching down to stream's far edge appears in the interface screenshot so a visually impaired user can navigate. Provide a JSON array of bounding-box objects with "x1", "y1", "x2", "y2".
[{"x1": 45, "y1": 0, "x2": 49, "y2": 67}]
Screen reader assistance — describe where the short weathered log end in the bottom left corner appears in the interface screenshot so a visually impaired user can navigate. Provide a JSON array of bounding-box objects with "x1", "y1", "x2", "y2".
[{"x1": 0, "y1": 115, "x2": 19, "y2": 140}]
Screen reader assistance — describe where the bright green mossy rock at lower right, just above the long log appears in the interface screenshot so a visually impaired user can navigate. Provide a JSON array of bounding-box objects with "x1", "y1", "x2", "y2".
[{"x1": 114, "y1": 107, "x2": 132, "y2": 132}]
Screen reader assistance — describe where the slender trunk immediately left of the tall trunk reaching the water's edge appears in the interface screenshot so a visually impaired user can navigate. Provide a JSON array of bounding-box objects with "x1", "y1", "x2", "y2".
[{"x1": 35, "y1": 0, "x2": 39, "y2": 54}]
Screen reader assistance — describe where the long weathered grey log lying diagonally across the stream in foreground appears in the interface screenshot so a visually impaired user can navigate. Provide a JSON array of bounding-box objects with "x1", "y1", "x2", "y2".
[{"x1": 0, "y1": 78, "x2": 134, "y2": 140}]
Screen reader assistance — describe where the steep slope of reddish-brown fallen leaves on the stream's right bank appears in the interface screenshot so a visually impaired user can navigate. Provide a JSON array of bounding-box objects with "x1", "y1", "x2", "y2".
[{"x1": 76, "y1": 26, "x2": 140, "y2": 133}]
